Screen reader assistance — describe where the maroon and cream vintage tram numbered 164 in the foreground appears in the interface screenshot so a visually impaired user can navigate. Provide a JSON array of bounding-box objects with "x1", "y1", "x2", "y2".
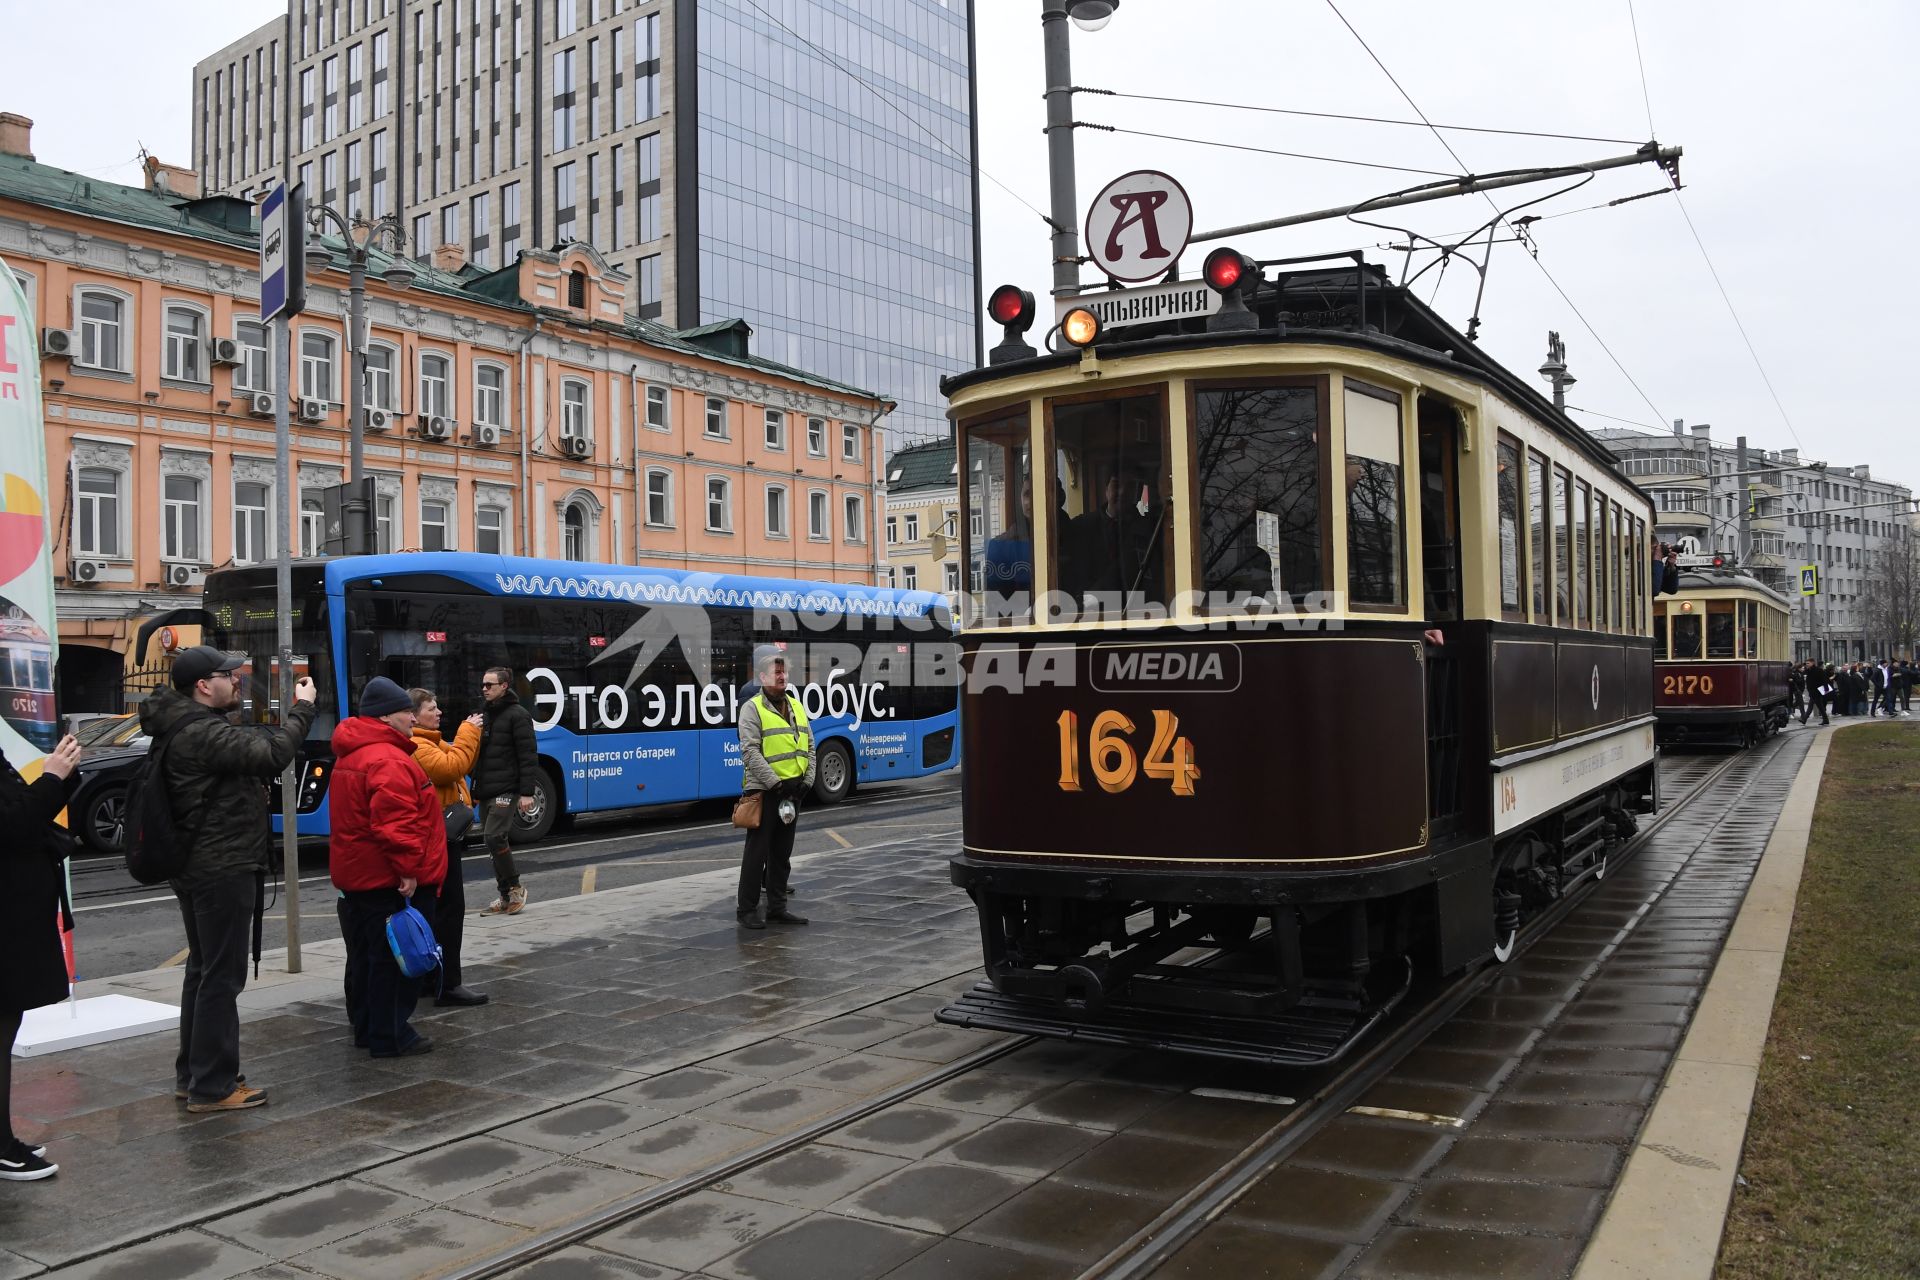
[{"x1": 939, "y1": 249, "x2": 1655, "y2": 1063}]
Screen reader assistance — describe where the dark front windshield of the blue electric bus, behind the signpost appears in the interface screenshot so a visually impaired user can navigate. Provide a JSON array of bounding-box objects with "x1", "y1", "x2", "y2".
[{"x1": 205, "y1": 564, "x2": 340, "y2": 739}]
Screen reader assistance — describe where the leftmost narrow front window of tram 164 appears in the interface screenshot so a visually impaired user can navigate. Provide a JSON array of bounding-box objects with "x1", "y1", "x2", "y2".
[{"x1": 960, "y1": 409, "x2": 1035, "y2": 626}]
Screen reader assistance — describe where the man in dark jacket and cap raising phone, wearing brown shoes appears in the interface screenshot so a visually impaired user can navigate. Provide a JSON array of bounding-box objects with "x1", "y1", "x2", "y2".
[{"x1": 140, "y1": 645, "x2": 315, "y2": 1111}]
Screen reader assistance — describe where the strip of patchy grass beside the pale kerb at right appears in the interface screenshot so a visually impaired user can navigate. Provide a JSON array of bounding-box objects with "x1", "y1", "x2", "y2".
[{"x1": 1715, "y1": 723, "x2": 1920, "y2": 1280}]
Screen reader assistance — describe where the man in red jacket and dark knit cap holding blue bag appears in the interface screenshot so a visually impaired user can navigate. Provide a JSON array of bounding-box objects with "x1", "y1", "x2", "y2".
[{"x1": 328, "y1": 676, "x2": 447, "y2": 1057}]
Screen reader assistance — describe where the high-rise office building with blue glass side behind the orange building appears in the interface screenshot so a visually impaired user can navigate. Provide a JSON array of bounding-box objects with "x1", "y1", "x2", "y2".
[{"x1": 194, "y1": 0, "x2": 979, "y2": 438}]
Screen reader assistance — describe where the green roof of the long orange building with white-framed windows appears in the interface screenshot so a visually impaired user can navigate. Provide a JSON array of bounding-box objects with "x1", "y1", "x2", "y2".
[{"x1": 0, "y1": 154, "x2": 885, "y2": 401}]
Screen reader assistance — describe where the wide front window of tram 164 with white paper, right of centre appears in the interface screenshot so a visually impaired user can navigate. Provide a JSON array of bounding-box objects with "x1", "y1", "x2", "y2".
[{"x1": 1194, "y1": 384, "x2": 1327, "y2": 608}]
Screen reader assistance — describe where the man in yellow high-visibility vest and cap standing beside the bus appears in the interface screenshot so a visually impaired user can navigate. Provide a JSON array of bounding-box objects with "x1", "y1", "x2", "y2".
[{"x1": 735, "y1": 645, "x2": 814, "y2": 929}]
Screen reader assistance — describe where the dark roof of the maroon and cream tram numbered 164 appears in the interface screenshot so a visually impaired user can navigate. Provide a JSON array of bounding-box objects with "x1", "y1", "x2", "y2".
[{"x1": 941, "y1": 262, "x2": 1638, "y2": 487}]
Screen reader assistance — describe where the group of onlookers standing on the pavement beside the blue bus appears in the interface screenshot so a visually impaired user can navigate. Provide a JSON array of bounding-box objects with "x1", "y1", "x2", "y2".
[{"x1": 0, "y1": 645, "x2": 816, "y2": 1182}]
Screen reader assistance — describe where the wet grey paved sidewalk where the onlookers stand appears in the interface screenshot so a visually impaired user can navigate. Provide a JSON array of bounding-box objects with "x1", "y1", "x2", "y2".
[{"x1": 0, "y1": 827, "x2": 981, "y2": 1280}]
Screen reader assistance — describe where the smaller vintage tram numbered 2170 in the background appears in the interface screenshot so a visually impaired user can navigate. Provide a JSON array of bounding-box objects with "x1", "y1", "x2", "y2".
[{"x1": 1653, "y1": 557, "x2": 1791, "y2": 747}]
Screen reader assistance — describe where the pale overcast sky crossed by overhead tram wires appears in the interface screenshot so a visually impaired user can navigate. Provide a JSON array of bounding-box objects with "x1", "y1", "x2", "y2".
[{"x1": 0, "y1": 0, "x2": 1920, "y2": 486}]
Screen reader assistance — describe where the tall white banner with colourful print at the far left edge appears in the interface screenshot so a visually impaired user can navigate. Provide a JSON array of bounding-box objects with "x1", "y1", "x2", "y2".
[{"x1": 0, "y1": 259, "x2": 60, "y2": 777}]
